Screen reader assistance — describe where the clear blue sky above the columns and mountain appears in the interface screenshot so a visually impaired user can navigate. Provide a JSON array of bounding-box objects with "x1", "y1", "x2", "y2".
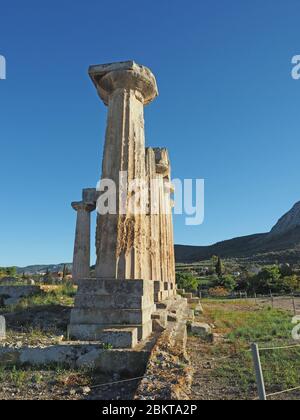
[{"x1": 0, "y1": 0, "x2": 300, "y2": 265}]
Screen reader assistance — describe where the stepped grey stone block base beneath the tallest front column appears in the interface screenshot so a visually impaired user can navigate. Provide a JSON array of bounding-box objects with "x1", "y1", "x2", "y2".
[{"x1": 69, "y1": 278, "x2": 156, "y2": 347}]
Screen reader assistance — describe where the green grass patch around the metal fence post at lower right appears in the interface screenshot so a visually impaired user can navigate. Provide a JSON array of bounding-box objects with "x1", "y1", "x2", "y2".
[{"x1": 205, "y1": 301, "x2": 300, "y2": 396}]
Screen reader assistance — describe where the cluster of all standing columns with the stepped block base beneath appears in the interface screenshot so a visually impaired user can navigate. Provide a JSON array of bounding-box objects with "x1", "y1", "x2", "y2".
[{"x1": 69, "y1": 61, "x2": 177, "y2": 348}]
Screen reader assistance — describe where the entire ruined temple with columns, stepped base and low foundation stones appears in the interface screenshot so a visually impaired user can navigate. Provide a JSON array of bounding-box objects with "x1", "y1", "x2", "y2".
[{"x1": 0, "y1": 62, "x2": 202, "y2": 399}]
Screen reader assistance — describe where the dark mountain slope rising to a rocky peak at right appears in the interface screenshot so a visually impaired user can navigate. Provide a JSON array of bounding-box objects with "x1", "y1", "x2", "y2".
[{"x1": 175, "y1": 202, "x2": 300, "y2": 263}]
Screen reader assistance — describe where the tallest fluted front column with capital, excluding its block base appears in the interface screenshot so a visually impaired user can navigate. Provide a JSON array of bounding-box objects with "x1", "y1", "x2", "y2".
[{"x1": 89, "y1": 62, "x2": 158, "y2": 280}]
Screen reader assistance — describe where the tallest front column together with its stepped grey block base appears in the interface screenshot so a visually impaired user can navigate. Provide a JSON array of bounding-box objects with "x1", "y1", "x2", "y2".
[{"x1": 69, "y1": 61, "x2": 167, "y2": 348}]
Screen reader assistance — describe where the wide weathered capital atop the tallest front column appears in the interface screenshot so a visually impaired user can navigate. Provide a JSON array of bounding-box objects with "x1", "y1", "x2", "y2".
[{"x1": 89, "y1": 61, "x2": 158, "y2": 105}]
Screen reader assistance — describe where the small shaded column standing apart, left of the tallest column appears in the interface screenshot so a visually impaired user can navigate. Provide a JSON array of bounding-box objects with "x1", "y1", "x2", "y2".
[{"x1": 72, "y1": 201, "x2": 95, "y2": 281}]
